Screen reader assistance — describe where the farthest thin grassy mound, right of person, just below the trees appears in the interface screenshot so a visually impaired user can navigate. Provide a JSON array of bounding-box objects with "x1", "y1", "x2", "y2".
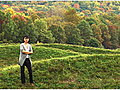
[{"x1": 36, "y1": 44, "x2": 120, "y2": 54}]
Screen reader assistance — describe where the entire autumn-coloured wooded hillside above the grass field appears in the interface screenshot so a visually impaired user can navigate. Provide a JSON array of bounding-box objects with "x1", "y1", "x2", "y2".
[{"x1": 0, "y1": 1, "x2": 120, "y2": 49}]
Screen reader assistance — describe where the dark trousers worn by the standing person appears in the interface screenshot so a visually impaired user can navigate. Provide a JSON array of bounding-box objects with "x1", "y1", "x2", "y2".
[{"x1": 20, "y1": 58, "x2": 33, "y2": 83}]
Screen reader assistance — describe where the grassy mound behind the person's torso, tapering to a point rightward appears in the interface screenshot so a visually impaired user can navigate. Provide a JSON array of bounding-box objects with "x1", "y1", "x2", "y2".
[{"x1": 0, "y1": 46, "x2": 77, "y2": 67}]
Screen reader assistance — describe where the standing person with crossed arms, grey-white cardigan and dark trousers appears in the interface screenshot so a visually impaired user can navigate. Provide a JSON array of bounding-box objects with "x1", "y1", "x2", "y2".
[{"x1": 19, "y1": 35, "x2": 34, "y2": 86}]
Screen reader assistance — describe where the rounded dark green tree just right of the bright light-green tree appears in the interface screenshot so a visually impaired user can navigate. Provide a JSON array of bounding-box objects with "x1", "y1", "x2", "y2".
[{"x1": 48, "y1": 24, "x2": 66, "y2": 43}]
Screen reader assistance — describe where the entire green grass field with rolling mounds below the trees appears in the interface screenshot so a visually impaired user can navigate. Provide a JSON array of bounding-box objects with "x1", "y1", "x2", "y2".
[{"x1": 0, "y1": 44, "x2": 120, "y2": 89}]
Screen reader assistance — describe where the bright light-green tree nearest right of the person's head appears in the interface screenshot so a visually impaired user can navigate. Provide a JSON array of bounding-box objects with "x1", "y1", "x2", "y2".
[{"x1": 34, "y1": 19, "x2": 55, "y2": 43}]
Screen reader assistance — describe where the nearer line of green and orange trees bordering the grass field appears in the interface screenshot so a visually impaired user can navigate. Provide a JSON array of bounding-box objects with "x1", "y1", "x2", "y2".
[{"x1": 0, "y1": 7, "x2": 120, "y2": 49}]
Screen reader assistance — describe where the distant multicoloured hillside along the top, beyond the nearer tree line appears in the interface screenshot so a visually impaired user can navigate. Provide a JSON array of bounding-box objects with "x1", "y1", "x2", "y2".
[{"x1": 0, "y1": 1, "x2": 120, "y2": 17}]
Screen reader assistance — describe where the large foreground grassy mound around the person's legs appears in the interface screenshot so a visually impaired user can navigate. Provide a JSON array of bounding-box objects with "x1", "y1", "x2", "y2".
[{"x1": 0, "y1": 55, "x2": 120, "y2": 89}]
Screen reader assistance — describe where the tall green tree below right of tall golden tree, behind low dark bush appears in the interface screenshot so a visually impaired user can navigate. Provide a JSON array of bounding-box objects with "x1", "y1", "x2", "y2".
[{"x1": 77, "y1": 20, "x2": 93, "y2": 46}]
